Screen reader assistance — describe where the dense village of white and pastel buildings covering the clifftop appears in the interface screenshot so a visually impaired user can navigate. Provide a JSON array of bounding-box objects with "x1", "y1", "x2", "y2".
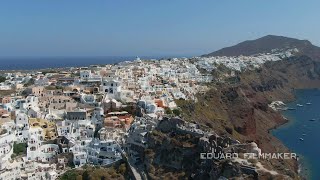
[{"x1": 0, "y1": 51, "x2": 296, "y2": 180}]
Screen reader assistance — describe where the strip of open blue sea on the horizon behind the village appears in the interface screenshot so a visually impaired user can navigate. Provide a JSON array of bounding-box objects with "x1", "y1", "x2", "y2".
[{"x1": 0, "y1": 56, "x2": 175, "y2": 70}]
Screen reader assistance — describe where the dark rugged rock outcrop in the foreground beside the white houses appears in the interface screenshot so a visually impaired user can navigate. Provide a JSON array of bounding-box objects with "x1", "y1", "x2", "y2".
[{"x1": 143, "y1": 118, "x2": 264, "y2": 179}]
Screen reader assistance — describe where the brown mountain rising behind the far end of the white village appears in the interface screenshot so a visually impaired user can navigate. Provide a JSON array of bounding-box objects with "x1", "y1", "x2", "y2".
[{"x1": 203, "y1": 35, "x2": 320, "y2": 60}]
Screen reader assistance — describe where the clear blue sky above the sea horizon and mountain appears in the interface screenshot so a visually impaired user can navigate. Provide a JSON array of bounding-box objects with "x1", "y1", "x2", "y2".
[{"x1": 0, "y1": 0, "x2": 320, "y2": 56}]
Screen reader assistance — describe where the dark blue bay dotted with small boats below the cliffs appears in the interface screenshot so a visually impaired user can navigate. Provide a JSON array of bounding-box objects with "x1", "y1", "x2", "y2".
[{"x1": 272, "y1": 89, "x2": 320, "y2": 180}]
